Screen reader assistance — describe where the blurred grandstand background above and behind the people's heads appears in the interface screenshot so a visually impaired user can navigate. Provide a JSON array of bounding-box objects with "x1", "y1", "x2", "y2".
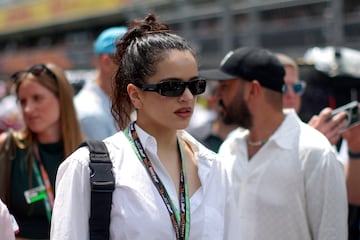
[{"x1": 0, "y1": 0, "x2": 360, "y2": 118}]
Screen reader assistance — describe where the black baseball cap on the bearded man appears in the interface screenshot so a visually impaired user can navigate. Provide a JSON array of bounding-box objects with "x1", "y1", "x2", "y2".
[{"x1": 200, "y1": 47, "x2": 285, "y2": 93}]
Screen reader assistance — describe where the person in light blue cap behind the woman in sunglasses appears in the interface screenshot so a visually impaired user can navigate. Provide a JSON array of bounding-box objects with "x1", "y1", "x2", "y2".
[{"x1": 75, "y1": 27, "x2": 127, "y2": 140}]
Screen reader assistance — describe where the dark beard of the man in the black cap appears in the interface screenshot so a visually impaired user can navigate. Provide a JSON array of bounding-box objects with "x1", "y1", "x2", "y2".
[{"x1": 219, "y1": 94, "x2": 253, "y2": 129}]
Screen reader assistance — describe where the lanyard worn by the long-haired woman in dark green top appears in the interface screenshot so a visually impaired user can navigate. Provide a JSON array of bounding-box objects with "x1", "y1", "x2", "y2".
[{"x1": 33, "y1": 145, "x2": 54, "y2": 222}]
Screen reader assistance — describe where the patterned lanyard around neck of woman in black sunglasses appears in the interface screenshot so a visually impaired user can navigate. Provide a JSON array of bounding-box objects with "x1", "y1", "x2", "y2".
[{"x1": 125, "y1": 122, "x2": 190, "y2": 240}]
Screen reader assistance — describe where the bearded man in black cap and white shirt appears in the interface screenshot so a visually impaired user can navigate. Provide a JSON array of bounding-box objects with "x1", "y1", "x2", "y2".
[{"x1": 200, "y1": 47, "x2": 347, "y2": 240}]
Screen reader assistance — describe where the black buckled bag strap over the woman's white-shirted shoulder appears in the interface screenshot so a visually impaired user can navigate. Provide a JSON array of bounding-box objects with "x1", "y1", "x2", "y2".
[{"x1": 79, "y1": 140, "x2": 115, "y2": 240}]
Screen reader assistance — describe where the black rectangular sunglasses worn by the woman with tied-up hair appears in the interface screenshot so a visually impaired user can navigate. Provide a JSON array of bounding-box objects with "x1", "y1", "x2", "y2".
[{"x1": 136, "y1": 78, "x2": 206, "y2": 97}]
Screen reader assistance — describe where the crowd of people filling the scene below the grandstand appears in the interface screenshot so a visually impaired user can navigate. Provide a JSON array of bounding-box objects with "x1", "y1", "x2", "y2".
[{"x1": 0, "y1": 14, "x2": 360, "y2": 240}]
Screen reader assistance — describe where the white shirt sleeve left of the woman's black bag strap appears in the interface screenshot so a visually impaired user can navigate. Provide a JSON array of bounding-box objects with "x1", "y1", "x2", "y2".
[{"x1": 50, "y1": 148, "x2": 90, "y2": 240}]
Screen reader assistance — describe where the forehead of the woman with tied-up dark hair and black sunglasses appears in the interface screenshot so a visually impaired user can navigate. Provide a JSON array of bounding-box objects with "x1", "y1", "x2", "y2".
[{"x1": 150, "y1": 50, "x2": 198, "y2": 82}]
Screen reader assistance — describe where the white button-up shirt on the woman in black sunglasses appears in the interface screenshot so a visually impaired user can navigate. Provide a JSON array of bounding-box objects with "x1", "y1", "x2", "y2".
[{"x1": 51, "y1": 125, "x2": 239, "y2": 240}]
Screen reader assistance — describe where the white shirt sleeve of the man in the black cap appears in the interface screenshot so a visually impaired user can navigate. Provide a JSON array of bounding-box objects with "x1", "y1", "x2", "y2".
[{"x1": 305, "y1": 151, "x2": 348, "y2": 240}]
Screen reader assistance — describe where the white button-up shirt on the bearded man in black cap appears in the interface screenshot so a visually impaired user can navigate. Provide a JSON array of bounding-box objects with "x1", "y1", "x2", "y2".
[{"x1": 219, "y1": 111, "x2": 348, "y2": 240}]
